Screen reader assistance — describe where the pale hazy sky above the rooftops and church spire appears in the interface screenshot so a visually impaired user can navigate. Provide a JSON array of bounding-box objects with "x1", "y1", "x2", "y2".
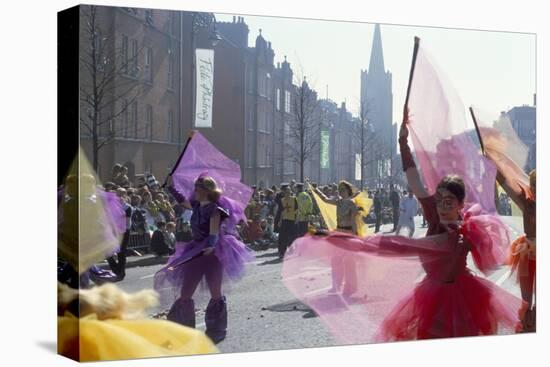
[{"x1": 216, "y1": 14, "x2": 536, "y2": 121}]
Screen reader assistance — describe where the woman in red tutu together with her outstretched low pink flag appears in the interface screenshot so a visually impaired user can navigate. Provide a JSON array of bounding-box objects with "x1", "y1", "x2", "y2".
[{"x1": 283, "y1": 113, "x2": 526, "y2": 343}]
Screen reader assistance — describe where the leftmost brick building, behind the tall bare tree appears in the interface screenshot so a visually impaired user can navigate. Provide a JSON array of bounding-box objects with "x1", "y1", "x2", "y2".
[{"x1": 80, "y1": 5, "x2": 181, "y2": 182}]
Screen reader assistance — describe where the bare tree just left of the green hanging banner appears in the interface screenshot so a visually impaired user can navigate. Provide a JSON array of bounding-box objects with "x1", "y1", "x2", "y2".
[{"x1": 284, "y1": 77, "x2": 321, "y2": 181}]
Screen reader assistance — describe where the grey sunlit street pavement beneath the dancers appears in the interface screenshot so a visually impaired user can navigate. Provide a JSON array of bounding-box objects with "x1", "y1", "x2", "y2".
[{"x1": 111, "y1": 217, "x2": 523, "y2": 352}]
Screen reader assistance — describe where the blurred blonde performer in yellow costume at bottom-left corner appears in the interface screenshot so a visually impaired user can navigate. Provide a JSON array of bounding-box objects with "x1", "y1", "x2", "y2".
[{"x1": 57, "y1": 283, "x2": 218, "y2": 362}]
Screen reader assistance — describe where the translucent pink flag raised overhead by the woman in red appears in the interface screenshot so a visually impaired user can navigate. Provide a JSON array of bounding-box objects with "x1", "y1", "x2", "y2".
[{"x1": 408, "y1": 40, "x2": 496, "y2": 213}]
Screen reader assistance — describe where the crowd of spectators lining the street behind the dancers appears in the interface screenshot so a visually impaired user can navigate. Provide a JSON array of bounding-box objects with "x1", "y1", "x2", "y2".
[{"x1": 104, "y1": 164, "x2": 418, "y2": 269}]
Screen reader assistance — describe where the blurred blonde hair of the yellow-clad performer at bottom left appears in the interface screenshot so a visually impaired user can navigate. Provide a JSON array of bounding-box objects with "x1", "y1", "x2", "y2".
[{"x1": 57, "y1": 282, "x2": 158, "y2": 320}]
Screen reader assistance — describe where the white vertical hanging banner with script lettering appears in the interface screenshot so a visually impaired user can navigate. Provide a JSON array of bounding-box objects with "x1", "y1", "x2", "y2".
[{"x1": 195, "y1": 48, "x2": 214, "y2": 127}]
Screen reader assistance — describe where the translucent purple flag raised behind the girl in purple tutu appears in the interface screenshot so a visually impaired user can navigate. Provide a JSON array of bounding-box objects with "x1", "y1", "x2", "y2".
[{"x1": 172, "y1": 132, "x2": 252, "y2": 225}]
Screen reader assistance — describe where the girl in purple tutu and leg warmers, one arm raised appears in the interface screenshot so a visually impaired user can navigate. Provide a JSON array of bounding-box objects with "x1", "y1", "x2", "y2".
[{"x1": 155, "y1": 175, "x2": 253, "y2": 343}]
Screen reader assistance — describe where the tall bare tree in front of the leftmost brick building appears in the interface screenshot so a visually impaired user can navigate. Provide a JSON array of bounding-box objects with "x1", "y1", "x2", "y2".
[{"x1": 80, "y1": 5, "x2": 146, "y2": 171}]
